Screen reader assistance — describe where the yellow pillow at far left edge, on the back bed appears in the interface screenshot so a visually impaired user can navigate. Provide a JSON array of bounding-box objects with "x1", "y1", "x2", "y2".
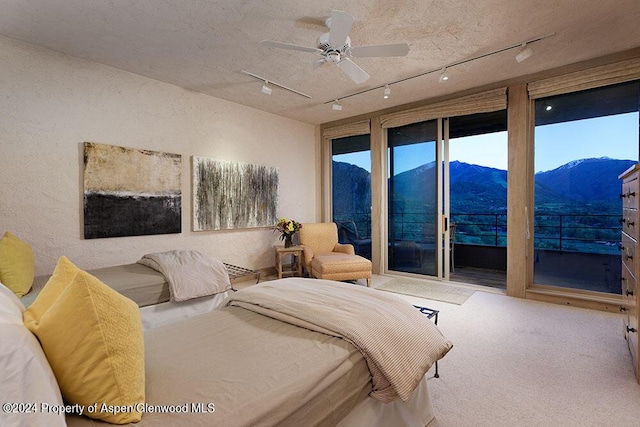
[{"x1": 0, "y1": 231, "x2": 36, "y2": 297}]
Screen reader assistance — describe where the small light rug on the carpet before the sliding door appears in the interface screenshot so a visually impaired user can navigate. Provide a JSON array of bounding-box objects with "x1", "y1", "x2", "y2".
[{"x1": 376, "y1": 279, "x2": 475, "y2": 305}]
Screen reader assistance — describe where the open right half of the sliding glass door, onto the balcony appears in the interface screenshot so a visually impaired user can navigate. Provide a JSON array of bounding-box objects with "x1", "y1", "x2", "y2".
[{"x1": 448, "y1": 110, "x2": 508, "y2": 289}]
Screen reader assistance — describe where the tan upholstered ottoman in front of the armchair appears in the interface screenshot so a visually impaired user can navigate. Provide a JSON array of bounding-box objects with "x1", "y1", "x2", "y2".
[{"x1": 311, "y1": 253, "x2": 371, "y2": 280}]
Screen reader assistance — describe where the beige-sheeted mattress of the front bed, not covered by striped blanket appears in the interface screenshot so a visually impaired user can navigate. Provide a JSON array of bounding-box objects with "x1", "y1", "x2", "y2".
[{"x1": 67, "y1": 307, "x2": 371, "y2": 427}]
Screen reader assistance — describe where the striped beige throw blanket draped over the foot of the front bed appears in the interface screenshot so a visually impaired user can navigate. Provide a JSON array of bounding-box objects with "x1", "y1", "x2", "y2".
[{"x1": 226, "y1": 278, "x2": 453, "y2": 403}]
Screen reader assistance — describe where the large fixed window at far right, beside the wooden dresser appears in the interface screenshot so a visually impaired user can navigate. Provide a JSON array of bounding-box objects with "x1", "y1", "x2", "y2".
[{"x1": 534, "y1": 81, "x2": 640, "y2": 294}]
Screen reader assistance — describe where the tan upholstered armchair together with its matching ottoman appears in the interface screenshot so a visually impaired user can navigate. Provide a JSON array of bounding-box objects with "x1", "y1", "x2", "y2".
[{"x1": 298, "y1": 222, "x2": 371, "y2": 286}]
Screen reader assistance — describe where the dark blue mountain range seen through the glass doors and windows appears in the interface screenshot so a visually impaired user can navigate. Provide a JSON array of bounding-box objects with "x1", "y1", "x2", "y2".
[{"x1": 333, "y1": 157, "x2": 636, "y2": 215}]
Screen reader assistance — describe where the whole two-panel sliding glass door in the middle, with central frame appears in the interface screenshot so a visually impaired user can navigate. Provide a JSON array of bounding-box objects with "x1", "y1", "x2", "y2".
[{"x1": 387, "y1": 110, "x2": 507, "y2": 287}]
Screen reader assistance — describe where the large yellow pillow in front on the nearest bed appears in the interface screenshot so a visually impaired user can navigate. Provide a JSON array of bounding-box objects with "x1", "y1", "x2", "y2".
[{"x1": 34, "y1": 271, "x2": 145, "y2": 424}]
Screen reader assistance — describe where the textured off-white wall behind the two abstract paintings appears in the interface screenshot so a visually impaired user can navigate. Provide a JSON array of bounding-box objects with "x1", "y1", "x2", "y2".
[{"x1": 0, "y1": 37, "x2": 319, "y2": 274}]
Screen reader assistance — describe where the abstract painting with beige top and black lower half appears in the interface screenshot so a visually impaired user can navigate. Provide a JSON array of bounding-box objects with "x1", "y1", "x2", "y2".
[{"x1": 84, "y1": 142, "x2": 182, "y2": 239}]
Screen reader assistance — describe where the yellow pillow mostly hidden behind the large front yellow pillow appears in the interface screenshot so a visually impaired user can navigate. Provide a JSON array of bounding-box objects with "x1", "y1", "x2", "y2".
[{"x1": 22, "y1": 256, "x2": 80, "y2": 334}]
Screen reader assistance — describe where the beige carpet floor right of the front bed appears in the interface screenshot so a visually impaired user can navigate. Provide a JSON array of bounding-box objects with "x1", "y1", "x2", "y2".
[{"x1": 384, "y1": 291, "x2": 640, "y2": 427}]
